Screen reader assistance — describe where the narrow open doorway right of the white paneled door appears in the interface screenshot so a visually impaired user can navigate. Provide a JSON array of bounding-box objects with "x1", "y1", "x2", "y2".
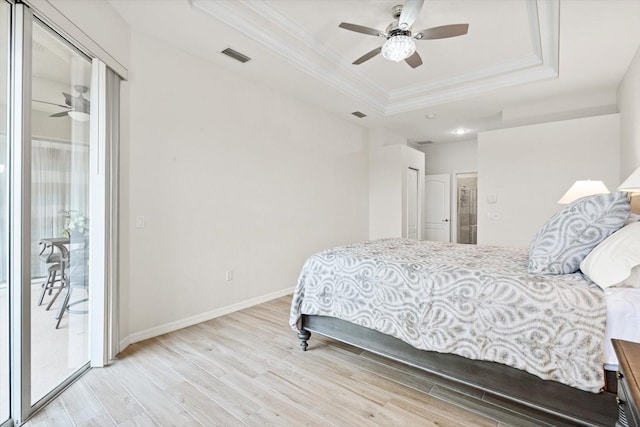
[{"x1": 456, "y1": 172, "x2": 478, "y2": 245}]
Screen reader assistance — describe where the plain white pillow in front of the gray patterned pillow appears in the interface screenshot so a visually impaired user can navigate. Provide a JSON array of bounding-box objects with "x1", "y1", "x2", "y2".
[{"x1": 580, "y1": 222, "x2": 640, "y2": 289}]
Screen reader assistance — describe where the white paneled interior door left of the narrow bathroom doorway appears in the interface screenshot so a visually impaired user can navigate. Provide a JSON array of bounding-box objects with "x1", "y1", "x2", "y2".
[{"x1": 424, "y1": 174, "x2": 451, "y2": 242}]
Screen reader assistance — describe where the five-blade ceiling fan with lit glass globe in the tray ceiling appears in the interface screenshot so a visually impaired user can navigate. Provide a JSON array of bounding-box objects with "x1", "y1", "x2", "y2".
[{"x1": 339, "y1": 0, "x2": 469, "y2": 68}]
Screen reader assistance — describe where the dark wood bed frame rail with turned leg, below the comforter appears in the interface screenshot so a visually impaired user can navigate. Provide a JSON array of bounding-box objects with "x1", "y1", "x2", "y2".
[{"x1": 298, "y1": 315, "x2": 618, "y2": 426}]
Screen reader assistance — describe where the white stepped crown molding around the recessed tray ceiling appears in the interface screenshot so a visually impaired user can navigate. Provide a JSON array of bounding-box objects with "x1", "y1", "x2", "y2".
[{"x1": 190, "y1": 0, "x2": 560, "y2": 115}]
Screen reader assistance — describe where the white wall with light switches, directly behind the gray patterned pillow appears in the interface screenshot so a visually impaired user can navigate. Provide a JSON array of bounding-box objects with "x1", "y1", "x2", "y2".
[{"x1": 478, "y1": 114, "x2": 620, "y2": 247}]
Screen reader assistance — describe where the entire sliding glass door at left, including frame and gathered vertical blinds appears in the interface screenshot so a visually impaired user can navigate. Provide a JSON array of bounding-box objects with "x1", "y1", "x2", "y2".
[{"x1": 0, "y1": 0, "x2": 119, "y2": 425}]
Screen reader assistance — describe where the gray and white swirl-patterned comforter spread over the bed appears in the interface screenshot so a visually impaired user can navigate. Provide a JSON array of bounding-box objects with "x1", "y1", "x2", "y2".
[{"x1": 290, "y1": 239, "x2": 606, "y2": 393}]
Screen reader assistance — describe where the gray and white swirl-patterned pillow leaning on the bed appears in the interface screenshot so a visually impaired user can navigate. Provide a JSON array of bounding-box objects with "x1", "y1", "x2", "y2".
[{"x1": 529, "y1": 192, "x2": 630, "y2": 274}]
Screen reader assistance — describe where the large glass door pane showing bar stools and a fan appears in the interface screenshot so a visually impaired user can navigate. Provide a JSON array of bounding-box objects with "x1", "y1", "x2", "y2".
[{"x1": 30, "y1": 23, "x2": 92, "y2": 404}]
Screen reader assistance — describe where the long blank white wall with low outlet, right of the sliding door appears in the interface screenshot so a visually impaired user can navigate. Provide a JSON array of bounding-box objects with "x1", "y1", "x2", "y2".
[{"x1": 129, "y1": 33, "x2": 368, "y2": 341}]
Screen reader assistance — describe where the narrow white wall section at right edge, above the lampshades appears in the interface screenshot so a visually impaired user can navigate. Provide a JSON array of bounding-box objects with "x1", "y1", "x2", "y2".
[{"x1": 618, "y1": 48, "x2": 640, "y2": 182}]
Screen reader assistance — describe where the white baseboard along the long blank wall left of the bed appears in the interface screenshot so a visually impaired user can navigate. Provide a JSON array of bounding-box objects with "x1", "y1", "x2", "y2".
[{"x1": 120, "y1": 288, "x2": 295, "y2": 351}]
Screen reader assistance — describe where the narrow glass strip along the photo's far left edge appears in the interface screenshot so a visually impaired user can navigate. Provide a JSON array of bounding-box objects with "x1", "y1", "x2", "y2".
[{"x1": 0, "y1": 1, "x2": 10, "y2": 423}]
